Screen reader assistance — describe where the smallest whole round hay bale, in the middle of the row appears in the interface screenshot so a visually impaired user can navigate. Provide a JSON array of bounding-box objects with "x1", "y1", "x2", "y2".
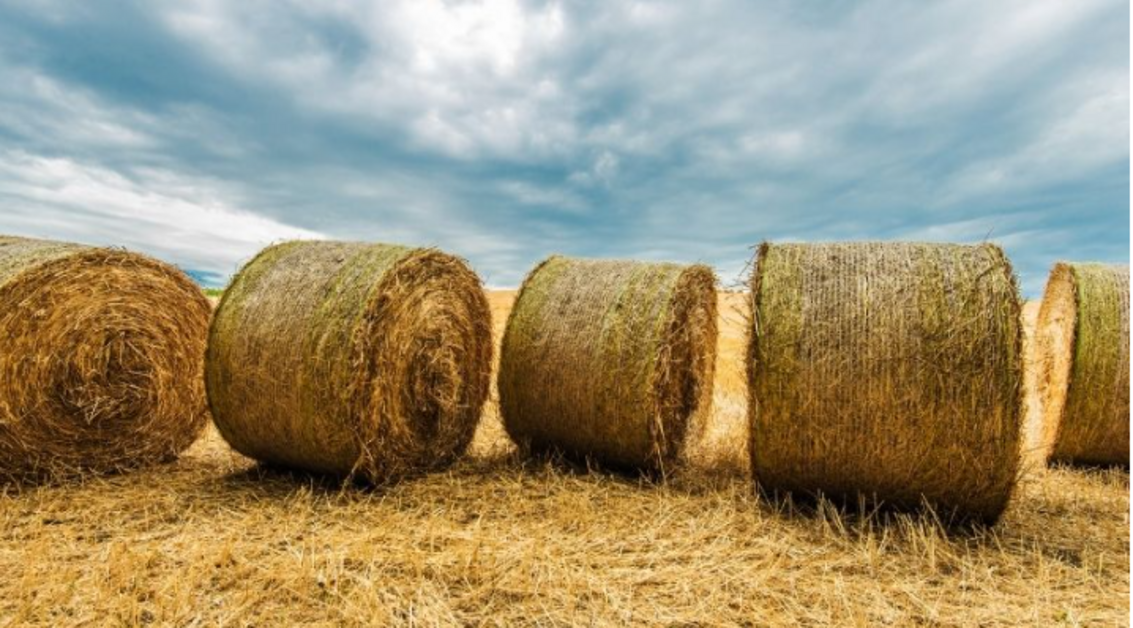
[{"x1": 499, "y1": 256, "x2": 716, "y2": 473}]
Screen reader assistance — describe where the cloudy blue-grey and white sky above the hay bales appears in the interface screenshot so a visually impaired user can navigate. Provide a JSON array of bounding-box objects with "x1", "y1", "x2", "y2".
[{"x1": 0, "y1": 0, "x2": 1130, "y2": 296}]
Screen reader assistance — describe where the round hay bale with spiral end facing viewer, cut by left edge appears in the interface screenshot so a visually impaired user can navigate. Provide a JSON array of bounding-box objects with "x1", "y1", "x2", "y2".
[{"x1": 0, "y1": 237, "x2": 211, "y2": 481}]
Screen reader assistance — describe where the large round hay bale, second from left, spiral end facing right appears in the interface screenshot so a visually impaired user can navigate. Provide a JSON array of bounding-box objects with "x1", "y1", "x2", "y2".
[{"x1": 206, "y1": 241, "x2": 492, "y2": 483}]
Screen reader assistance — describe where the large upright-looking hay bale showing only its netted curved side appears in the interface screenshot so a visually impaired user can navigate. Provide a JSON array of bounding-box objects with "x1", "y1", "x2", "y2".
[{"x1": 748, "y1": 243, "x2": 1023, "y2": 521}]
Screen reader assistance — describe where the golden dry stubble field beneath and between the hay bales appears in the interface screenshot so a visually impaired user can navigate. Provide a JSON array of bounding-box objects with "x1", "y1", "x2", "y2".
[{"x1": 0, "y1": 294, "x2": 1130, "y2": 626}]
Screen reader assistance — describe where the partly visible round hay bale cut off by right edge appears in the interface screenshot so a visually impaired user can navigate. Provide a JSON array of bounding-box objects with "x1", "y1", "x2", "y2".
[{"x1": 1037, "y1": 262, "x2": 1130, "y2": 465}]
